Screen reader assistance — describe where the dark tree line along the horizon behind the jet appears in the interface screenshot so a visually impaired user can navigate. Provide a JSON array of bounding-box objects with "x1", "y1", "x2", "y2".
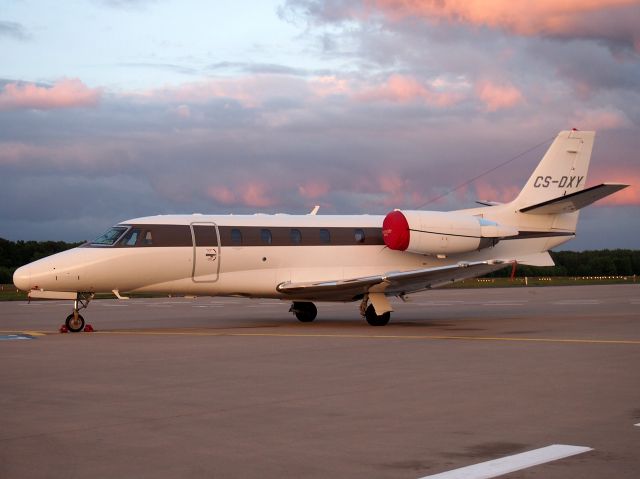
[{"x1": 0, "y1": 238, "x2": 640, "y2": 284}]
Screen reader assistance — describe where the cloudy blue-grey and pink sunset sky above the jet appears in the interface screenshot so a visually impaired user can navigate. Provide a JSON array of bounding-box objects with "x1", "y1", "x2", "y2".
[{"x1": 0, "y1": 0, "x2": 640, "y2": 250}]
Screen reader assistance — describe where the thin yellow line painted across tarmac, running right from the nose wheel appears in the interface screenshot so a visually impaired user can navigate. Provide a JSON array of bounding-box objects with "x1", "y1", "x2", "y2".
[{"x1": 94, "y1": 331, "x2": 640, "y2": 345}]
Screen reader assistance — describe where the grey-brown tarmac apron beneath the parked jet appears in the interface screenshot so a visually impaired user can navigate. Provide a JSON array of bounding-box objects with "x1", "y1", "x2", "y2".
[{"x1": 0, "y1": 285, "x2": 640, "y2": 479}]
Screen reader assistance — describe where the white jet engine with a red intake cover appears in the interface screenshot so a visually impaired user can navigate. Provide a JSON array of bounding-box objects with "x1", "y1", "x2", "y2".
[{"x1": 382, "y1": 210, "x2": 518, "y2": 255}]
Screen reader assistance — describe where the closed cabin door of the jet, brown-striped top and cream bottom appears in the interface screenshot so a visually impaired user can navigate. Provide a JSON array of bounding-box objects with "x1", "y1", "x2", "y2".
[{"x1": 191, "y1": 222, "x2": 220, "y2": 283}]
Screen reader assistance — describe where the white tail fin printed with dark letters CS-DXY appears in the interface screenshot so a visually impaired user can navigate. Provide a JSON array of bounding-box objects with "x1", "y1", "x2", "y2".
[{"x1": 512, "y1": 130, "x2": 596, "y2": 210}]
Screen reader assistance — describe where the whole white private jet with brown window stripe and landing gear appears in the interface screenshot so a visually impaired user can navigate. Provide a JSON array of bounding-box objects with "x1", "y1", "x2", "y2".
[{"x1": 13, "y1": 130, "x2": 628, "y2": 332}]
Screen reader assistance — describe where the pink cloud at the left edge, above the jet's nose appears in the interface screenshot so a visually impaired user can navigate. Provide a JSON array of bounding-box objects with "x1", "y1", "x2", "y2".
[{"x1": 0, "y1": 79, "x2": 101, "y2": 110}]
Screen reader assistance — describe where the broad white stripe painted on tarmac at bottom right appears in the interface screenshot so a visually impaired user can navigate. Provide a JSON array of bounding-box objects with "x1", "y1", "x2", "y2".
[{"x1": 420, "y1": 444, "x2": 593, "y2": 479}]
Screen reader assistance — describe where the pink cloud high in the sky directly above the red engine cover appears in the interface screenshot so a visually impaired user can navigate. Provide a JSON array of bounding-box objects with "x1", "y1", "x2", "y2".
[{"x1": 355, "y1": 74, "x2": 461, "y2": 107}]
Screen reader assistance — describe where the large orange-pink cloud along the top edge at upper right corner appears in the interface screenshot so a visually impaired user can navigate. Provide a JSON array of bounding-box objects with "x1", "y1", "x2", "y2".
[{"x1": 364, "y1": 0, "x2": 640, "y2": 50}]
